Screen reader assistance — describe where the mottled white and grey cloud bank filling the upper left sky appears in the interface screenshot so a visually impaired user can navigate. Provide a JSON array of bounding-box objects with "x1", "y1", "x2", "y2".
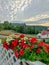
[{"x1": 0, "y1": 0, "x2": 32, "y2": 20}]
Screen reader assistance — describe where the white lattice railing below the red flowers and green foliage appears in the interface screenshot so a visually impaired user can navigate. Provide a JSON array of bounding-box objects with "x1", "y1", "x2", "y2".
[{"x1": 0, "y1": 45, "x2": 46, "y2": 65}]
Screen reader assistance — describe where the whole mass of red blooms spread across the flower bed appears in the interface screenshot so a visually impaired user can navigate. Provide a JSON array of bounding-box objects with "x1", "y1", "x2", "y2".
[{"x1": 3, "y1": 34, "x2": 49, "y2": 58}]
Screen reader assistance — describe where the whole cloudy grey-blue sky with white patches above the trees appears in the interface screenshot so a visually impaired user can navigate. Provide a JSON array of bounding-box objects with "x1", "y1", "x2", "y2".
[{"x1": 0, "y1": 0, "x2": 49, "y2": 23}]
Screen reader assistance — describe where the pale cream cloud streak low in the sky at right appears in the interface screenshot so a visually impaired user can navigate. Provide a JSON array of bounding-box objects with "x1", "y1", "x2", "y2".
[{"x1": 22, "y1": 14, "x2": 49, "y2": 22}]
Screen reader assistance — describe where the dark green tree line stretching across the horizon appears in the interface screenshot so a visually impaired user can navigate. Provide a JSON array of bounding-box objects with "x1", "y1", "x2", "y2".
[{"x1": 0, "y1": 21, "x2": 47, "y2": 34}]
